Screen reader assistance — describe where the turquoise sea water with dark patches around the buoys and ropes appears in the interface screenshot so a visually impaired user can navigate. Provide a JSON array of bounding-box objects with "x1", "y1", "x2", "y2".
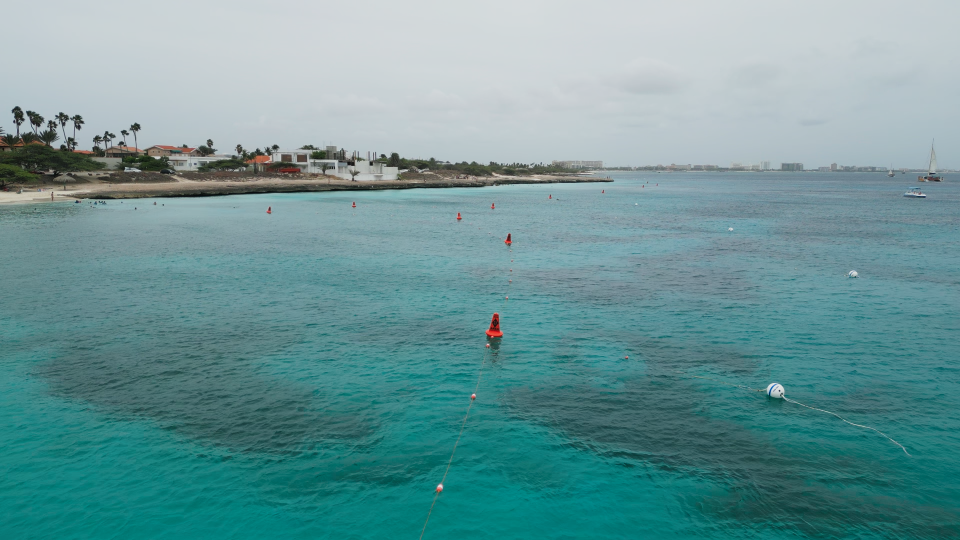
[{"x1": 0, "y1": 174, "x2": 960, "y2": 539}]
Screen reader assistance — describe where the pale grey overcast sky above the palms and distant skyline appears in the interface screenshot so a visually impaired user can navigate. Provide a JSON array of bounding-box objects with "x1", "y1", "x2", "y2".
[{"x1": 0, "y1": 0, "x2": 960, "y2": 168}]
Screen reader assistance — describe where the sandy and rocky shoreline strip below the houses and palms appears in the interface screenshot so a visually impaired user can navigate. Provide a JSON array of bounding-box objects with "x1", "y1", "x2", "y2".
[{"x1": 0, "y1": 175, "x2": 613, "y2": 204}]
